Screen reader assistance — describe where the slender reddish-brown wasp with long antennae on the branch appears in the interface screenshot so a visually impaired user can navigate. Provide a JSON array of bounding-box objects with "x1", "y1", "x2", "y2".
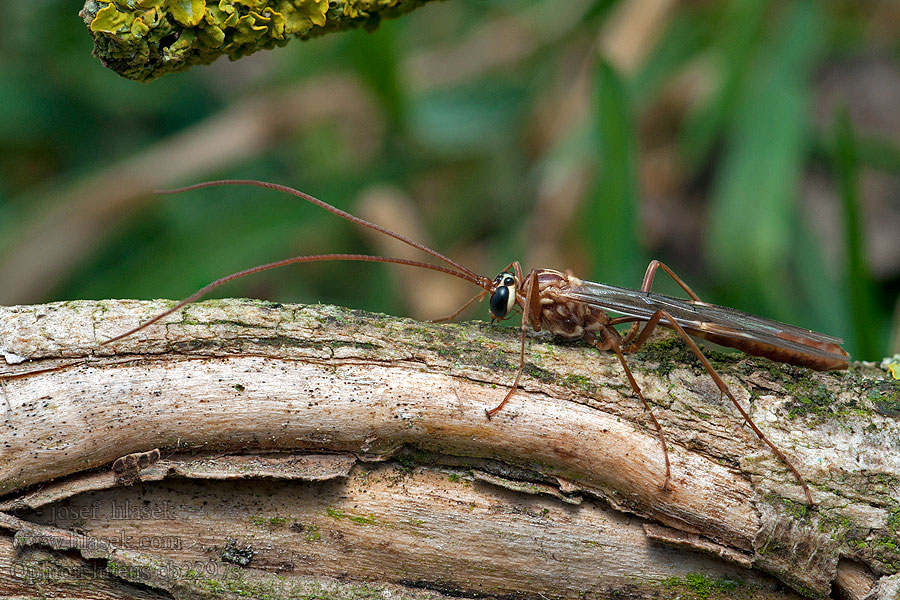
[{"x1": 103, "y1": 179, "x2": 849, "y2": 505}]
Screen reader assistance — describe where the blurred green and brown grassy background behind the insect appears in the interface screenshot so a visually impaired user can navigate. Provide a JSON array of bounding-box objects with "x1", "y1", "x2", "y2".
[{"x1": 0, "y1": 0, "x2": 900, "y2": 360}]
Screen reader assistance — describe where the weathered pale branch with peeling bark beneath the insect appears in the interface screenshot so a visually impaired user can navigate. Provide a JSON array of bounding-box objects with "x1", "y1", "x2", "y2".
[{"x1": 0, "y1": 300, "x2": 900, "y2": 600}]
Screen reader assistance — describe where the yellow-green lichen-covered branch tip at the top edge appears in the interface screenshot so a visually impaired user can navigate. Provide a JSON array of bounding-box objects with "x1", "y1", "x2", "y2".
[{"x1": 81, "y1": 0, "x2": 438, "y2": 81}]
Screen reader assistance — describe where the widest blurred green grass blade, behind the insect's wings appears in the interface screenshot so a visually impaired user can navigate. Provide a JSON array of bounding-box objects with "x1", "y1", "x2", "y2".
[{"x1": 706, "y1": 0, "x2": 822, "y2": 320}]
